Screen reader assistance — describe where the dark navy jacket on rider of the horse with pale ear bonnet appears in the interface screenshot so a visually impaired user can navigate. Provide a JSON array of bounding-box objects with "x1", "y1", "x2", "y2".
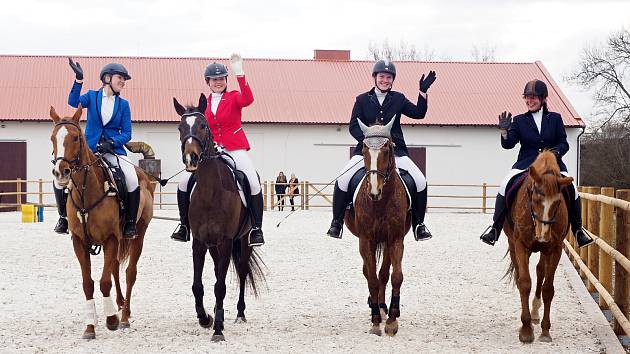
[{"x1": 348, "y1": 87, "x2": 427, "y2": 156}]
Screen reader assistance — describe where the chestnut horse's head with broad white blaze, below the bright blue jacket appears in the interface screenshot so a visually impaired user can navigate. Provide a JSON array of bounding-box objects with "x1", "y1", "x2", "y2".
[{"x1": 50, "y1": 104, "x2": 87, "y2": 187}]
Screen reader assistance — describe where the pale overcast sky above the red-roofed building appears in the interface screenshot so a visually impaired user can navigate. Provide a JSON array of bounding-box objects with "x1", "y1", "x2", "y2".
[{"x1": 0, "y1": 0, "x2": 630, "y2": 125}]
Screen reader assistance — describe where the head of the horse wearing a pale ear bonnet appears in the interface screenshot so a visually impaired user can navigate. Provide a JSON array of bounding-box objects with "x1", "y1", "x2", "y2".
[{"x1": 357, "y1": 118, "x2": 396, "y2": 201}]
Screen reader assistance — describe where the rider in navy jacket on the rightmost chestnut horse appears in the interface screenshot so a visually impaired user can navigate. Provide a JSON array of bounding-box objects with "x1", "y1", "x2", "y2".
[{"x1": 481, "y1": 80, "x2": 593, "y2": 247}]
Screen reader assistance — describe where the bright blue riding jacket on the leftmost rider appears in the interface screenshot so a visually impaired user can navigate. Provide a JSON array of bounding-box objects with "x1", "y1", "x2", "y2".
[{"x1": 68, "y1": 81, "x2": 131, "y2": 155}]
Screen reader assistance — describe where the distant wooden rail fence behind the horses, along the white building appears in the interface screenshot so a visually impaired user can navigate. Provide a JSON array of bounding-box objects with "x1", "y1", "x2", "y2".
[{"x1": 0, "y1": 179, "x2": 498, "y2": 213}]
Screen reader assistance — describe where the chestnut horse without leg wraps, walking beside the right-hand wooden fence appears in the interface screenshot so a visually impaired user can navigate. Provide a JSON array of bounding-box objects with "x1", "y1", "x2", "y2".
[{"x1": 503, "y1": 151, "x2": 573, "y2": 343}]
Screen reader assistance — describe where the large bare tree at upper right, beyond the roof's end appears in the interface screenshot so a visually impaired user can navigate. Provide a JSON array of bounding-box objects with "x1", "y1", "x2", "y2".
[{"x1": 566, "y1": 29, "x2": 630, "y2": 127}]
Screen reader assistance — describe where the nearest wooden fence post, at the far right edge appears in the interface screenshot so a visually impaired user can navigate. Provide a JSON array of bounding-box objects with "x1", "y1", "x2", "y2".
[{"x1": 613, "y1": 189, "x2": 630, "y2": 335}]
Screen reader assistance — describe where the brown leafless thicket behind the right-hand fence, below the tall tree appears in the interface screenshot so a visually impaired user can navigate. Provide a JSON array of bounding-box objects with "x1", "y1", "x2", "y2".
[{"x1": 580, "y1": 122, "x2": 630, "y2": 189}]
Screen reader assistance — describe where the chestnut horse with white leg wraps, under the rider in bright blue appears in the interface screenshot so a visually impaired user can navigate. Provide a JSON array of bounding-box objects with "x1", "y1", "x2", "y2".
[{"x1": 50, "y1": 105, "x2": 155, "y2": 339}]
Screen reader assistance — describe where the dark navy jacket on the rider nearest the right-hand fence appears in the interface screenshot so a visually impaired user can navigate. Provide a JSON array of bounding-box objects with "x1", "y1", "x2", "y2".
[{"x1": 501, "y1": 108, "x2": 569, "y2": 172}]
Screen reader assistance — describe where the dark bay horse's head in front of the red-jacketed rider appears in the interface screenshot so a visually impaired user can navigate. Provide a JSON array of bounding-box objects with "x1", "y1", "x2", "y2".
[{"x1": 173, "y1": 93, "x2": 217, "y2": 172}]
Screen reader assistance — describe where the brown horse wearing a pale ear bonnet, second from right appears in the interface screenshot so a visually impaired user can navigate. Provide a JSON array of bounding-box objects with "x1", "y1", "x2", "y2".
[{"x1": 345, "y1": 119, "x2": 411, "y2": 336}]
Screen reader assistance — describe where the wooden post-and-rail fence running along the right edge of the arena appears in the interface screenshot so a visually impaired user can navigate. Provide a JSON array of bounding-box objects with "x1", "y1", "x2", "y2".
[{"x1": 564, "y1": 187, "x2": 630, "y2": 336}]
